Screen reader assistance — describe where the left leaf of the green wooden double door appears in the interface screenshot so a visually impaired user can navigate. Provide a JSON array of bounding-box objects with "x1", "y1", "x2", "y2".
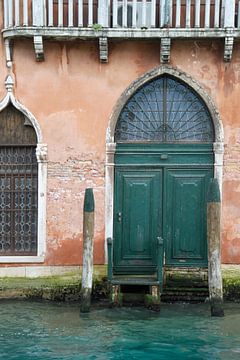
[{"x1": 114, "y1": 168, "x2": 162, "y2": 274}]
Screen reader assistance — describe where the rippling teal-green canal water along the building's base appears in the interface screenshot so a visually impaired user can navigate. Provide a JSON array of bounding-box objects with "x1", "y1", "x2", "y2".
[{"x1": 0, "y1": 301, "x2": 240, "y2": 360}]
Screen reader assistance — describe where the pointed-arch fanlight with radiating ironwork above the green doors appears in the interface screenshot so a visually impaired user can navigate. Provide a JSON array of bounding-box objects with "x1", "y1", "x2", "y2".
[{"x1": 115, "y1": 76, "x2": 214, "y2": 143}]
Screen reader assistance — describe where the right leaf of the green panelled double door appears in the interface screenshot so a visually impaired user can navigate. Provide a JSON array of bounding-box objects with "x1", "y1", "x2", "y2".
[{"x1": 164, "y1": 168, "x2": 212, "y2": 266}]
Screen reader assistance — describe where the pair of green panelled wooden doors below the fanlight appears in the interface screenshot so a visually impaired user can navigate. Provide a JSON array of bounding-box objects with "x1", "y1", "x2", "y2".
[{"x1": 114, "y1": 150, "x2": 212, "y2": 274}]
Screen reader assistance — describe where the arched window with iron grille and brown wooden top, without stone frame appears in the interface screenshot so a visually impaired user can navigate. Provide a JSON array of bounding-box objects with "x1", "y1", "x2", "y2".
[{"x1": 0, "y1": 105, "x2": 38, "y2": 256}]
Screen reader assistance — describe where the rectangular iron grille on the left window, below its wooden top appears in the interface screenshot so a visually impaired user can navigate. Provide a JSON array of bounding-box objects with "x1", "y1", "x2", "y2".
[{"x1": 0, "y1": 146, "x2": 38, "y2": 255}]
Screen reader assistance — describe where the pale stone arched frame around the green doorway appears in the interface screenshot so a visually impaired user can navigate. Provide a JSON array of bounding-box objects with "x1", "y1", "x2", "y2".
[{"x1": 105, "y1": 66, "x2": 224, "y2": 264}]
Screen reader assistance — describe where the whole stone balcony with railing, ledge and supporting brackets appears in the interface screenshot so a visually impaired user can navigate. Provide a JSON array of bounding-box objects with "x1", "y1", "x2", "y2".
[{"x1": 2, "y1": 0, "x2": 240, "y2": 66}]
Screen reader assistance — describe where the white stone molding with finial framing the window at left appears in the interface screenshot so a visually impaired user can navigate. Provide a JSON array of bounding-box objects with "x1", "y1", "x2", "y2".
[{"x1": 0, "y1": 75, "x2": 47, "y2": 263}]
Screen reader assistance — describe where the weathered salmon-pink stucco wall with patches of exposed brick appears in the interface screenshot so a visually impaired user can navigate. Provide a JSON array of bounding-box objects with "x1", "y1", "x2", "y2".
[{"x1": 0, "y1": 35, "x2": 240, "y2": 265}]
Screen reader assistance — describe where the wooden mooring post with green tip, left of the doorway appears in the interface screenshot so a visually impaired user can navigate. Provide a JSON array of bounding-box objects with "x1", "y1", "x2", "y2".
[{"x1": 80, "y1": 188, "x2": 94, "y2": 312}]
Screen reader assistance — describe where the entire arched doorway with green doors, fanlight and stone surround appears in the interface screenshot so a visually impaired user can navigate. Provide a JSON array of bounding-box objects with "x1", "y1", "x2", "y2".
[{"x1": 106, "y1": 69, "x2": 222, "y2": 284}]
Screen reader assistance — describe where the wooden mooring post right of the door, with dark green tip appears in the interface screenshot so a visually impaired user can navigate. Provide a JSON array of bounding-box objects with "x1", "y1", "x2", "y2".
[{"x1": 207, "y1": 179, "x2": 224, "y2": 316}]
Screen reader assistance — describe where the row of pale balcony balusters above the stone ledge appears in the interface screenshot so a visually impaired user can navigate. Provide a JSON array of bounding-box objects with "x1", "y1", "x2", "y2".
[{"x1": 4, "y1": 0, "x2": 240, "y2": 29}]
